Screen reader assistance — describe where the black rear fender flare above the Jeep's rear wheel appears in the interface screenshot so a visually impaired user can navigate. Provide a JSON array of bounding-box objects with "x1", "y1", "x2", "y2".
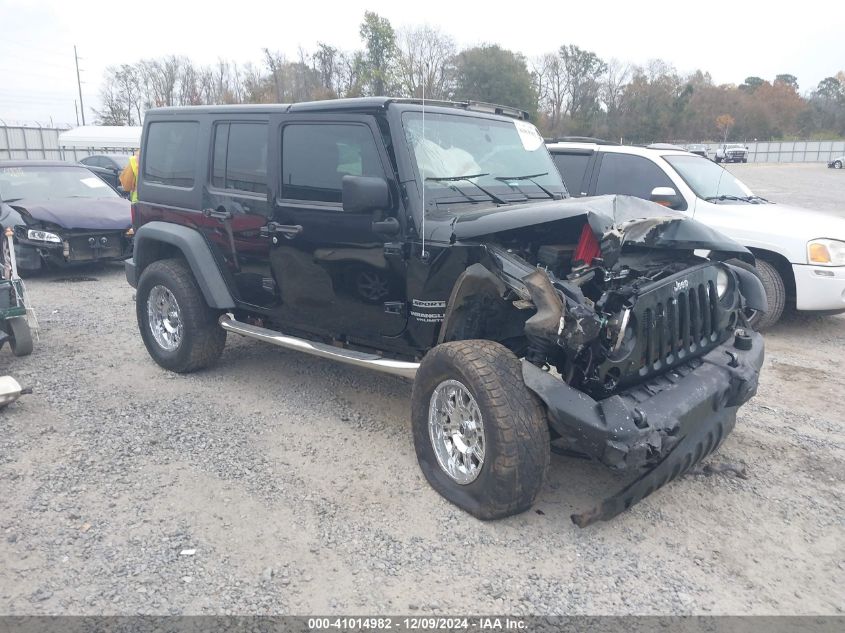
[{"x1": 127, "y1": 222, "x2": 235, "y2": 310}]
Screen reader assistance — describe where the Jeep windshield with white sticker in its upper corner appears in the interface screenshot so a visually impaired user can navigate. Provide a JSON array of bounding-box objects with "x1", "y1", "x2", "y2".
[{"x1": 402, "y1": 112, "x2": 566, "y2": 210}]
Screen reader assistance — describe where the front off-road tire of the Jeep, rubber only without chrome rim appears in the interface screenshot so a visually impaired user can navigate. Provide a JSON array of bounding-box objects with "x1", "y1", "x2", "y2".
[{"x1": 411, "y1": 340, "x2": 550, "y2": 520}]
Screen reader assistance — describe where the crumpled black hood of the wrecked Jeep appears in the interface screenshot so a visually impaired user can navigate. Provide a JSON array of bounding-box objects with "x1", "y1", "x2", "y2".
[{"x1": 426, "y1": 195, "x2": 750, "y2": 260}]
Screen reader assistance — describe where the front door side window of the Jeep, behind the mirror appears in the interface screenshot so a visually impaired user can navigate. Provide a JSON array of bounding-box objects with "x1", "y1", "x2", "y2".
[{"x1": 282, "y1": 123, "x2": 384, "y2": 203}]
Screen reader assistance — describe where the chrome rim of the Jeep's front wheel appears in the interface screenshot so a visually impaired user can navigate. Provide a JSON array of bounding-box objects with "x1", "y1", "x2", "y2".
[{"x1": 428, "y1": 380, "x2": 485, "y2": 485}]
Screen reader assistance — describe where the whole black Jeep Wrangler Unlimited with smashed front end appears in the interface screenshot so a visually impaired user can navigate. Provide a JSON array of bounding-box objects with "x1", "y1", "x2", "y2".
[{"x1": 126, "y1": 98, "x2": 766, "y2": 526}]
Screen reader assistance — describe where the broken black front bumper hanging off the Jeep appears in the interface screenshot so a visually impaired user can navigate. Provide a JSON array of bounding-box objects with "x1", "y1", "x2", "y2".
[{"x1": 523, "y1": 332, "x2": 763, "y2": 527}]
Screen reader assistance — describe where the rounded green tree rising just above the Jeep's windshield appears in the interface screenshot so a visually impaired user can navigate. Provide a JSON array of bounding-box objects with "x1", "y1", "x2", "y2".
[{"x1": 455, "y1": 44, "x2": 537, "y2": 114}]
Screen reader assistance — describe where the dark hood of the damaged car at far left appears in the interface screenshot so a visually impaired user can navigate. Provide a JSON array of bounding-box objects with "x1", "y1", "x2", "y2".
[{"x1": 7, "y1": 198, "x2": 132, "y2": 230}]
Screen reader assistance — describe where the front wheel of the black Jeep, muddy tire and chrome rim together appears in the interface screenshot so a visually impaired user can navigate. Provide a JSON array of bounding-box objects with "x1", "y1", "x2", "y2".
[{"x1": 411, "y1": 340, "x2": 550, "y2": 519}]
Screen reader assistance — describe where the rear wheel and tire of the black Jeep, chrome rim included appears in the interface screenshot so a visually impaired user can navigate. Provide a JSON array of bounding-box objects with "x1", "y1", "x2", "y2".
[{"x1": 135, "y1": 259, "x2": 226, "y2": 373}]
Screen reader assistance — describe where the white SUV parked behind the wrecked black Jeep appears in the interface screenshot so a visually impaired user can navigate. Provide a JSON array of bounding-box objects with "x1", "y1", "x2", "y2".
[{"x1": 548, "y1": 142, "x2": 845, "y2": 329}]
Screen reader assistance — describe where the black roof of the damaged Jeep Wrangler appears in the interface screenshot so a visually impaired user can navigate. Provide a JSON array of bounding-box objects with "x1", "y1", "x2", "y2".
[{"x1": 147, "y1": 97, "x2": 528, "y2": 119}]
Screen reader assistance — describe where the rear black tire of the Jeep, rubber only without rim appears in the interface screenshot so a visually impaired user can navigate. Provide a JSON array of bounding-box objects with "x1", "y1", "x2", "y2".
[{"x1": 135, "y1": 259, "x2": 226, "y2": 374}]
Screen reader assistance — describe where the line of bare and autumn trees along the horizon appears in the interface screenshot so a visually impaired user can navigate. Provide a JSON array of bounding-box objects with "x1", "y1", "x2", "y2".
[{"x1": 95, "y1": 11, "x2": 845, "y2": 143}]
